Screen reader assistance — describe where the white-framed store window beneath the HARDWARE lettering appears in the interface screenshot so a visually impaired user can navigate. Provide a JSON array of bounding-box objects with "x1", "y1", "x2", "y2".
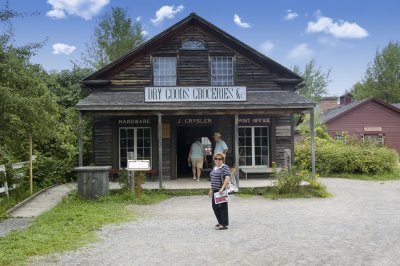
[{"x1": 119, "y1": 127, "x2": 151, "y2": 168}]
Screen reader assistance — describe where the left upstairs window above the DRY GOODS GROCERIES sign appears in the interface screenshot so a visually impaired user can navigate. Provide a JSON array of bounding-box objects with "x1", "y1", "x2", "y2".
[{"x1": 153, "y1": 57, "x2": 176, "y2": 86}]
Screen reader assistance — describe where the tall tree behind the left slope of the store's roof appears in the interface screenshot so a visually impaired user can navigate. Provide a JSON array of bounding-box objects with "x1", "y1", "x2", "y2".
[{"x1": 82, "y1": 7, "x2": 144, "y2": 69}]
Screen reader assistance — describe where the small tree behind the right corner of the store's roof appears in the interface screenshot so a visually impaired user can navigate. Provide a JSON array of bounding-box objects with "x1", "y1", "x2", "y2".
[{"x1": 293, "y1": 59, "x2": 331, "y2": 102}]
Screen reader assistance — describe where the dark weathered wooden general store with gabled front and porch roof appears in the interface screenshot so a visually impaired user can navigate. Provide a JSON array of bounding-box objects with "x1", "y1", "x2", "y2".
[{"x1": 77, "y1": 13, "x2": 315, "y2": 183}]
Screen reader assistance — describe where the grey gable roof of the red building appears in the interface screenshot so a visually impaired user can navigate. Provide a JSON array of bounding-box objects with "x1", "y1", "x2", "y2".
[{"x1": 320, "y1": 97, "x2": 400, "y2": 123}]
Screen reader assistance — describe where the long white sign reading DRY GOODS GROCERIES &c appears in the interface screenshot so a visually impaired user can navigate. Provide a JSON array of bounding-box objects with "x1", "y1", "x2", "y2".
[{"x1": 144, "y1": 86, "x2": 246, "y2": 102}]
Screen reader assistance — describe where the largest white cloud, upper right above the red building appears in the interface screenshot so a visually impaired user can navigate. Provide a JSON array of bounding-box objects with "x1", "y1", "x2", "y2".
[{"x1": 306, "y1": 14, "x2": 368, "y2": 39}]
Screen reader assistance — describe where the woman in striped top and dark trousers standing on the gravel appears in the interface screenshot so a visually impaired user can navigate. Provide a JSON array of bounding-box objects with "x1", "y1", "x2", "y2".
[{"x1": 208, "y1": 152, "x2": 230, "y2": 230}]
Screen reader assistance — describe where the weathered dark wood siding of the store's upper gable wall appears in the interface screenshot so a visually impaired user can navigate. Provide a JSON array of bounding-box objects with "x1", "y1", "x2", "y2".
[{"x1": 106, "y1": 26, "x2": 279, "y2": 90}]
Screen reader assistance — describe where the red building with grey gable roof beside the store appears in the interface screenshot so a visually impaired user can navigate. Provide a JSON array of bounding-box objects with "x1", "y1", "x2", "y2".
[{"x1": 321, "y1": 98, "x2": 400, "y2": 154}]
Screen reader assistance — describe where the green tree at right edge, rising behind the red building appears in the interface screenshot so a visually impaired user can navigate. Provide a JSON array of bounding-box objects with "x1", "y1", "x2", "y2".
[{"x1": 352, "y1": 42, "x2": 400, "y2": 103}]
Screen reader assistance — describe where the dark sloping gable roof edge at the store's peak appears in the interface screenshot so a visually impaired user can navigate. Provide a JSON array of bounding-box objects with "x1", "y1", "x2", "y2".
[{"x1": 82, "y1": 13, "x2": 303, "y2": 85}]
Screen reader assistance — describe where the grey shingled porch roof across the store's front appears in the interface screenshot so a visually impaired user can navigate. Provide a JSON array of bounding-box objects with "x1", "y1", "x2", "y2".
[{"x1": 77, "y1": 89, "x2": 315, "y2": 113}]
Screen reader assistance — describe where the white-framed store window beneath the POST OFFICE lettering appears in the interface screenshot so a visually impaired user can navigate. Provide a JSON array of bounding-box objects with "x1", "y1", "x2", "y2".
[{"x1": 239, "y1": 127, "x2": 269, "y2": 166}]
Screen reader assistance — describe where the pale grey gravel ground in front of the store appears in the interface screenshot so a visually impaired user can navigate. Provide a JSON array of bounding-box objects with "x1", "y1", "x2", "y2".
[{"x1": 30, "y1": 179, "x2": 400, "y2": 266}]
